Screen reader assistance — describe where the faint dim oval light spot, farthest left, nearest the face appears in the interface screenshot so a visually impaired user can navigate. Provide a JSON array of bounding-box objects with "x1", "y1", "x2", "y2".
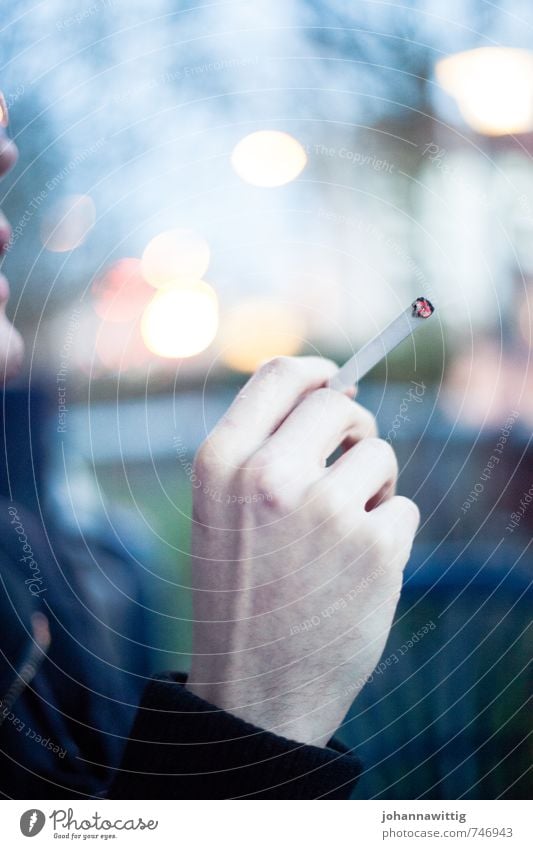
[{"x1": 41, "y1": 195, "x2": 96, "y2": 253}]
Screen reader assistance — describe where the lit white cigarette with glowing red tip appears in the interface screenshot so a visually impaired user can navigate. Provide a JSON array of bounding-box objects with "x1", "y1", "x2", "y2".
[{"x1": 328, "y1": 297, "x2": 435, "y2": 389}]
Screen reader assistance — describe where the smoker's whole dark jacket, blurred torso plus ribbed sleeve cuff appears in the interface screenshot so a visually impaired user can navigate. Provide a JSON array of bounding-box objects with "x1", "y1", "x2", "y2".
[{"x1": 0, "y1": 501, "x2": 360, "y2": 799}]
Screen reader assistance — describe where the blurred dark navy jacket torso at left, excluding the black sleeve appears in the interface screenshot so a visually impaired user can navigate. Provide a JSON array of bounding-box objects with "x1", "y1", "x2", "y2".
[{"x1": 0, "y1": 499, "x2": 146, "y2": 799}]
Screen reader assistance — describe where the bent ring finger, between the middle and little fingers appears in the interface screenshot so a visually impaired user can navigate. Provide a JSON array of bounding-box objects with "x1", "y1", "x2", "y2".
[{"x1": 324, "y1": 439, "x2": 398, "y2": 510}]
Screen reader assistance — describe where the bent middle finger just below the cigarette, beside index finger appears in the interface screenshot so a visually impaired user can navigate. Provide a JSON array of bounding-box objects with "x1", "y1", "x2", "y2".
[{"x1": 255, "y1": 388, "x2": 377, "y2": 468}]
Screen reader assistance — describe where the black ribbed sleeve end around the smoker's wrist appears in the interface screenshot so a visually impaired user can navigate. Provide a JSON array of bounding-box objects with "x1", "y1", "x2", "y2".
[{"x1": 108, "y1": 672, "x2": 361, "y2": 799}]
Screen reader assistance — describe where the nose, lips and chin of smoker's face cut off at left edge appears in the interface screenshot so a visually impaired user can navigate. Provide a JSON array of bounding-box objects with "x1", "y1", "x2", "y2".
[{"x1": 0, "y1": 94, "x2": 24, "y2": 380}]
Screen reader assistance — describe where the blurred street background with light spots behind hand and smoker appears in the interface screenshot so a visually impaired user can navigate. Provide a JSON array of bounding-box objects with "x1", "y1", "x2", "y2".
[{"x1": 0, "y1": 0, "x2": 533, "y2": 799}]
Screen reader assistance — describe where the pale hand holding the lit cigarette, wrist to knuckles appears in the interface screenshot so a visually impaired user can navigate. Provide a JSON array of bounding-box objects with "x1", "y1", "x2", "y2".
[{"x1": 188, "y1": 357, "x2": 419, "y2": 746}]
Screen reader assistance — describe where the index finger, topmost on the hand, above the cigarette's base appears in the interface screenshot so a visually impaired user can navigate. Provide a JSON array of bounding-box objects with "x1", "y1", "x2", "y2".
[{"x1": 204, "y1": 357, "x2": 337, "y2": 468}]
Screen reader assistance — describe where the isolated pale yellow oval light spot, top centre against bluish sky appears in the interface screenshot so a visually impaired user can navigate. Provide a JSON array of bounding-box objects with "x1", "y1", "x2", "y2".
[{"x1": 231, "y1": 130, "x2": 307, "y2": 188}]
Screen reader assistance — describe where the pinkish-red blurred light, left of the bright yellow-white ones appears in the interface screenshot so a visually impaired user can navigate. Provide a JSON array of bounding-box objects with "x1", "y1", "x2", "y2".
[{"x1": 92, "y1": 257, "x2": 153, "y2": 323}]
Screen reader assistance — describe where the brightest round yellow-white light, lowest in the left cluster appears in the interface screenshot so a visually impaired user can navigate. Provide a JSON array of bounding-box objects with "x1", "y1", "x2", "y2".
[{"x1": 141, "y1": 281, "x2": 218, "y2": 358}]
